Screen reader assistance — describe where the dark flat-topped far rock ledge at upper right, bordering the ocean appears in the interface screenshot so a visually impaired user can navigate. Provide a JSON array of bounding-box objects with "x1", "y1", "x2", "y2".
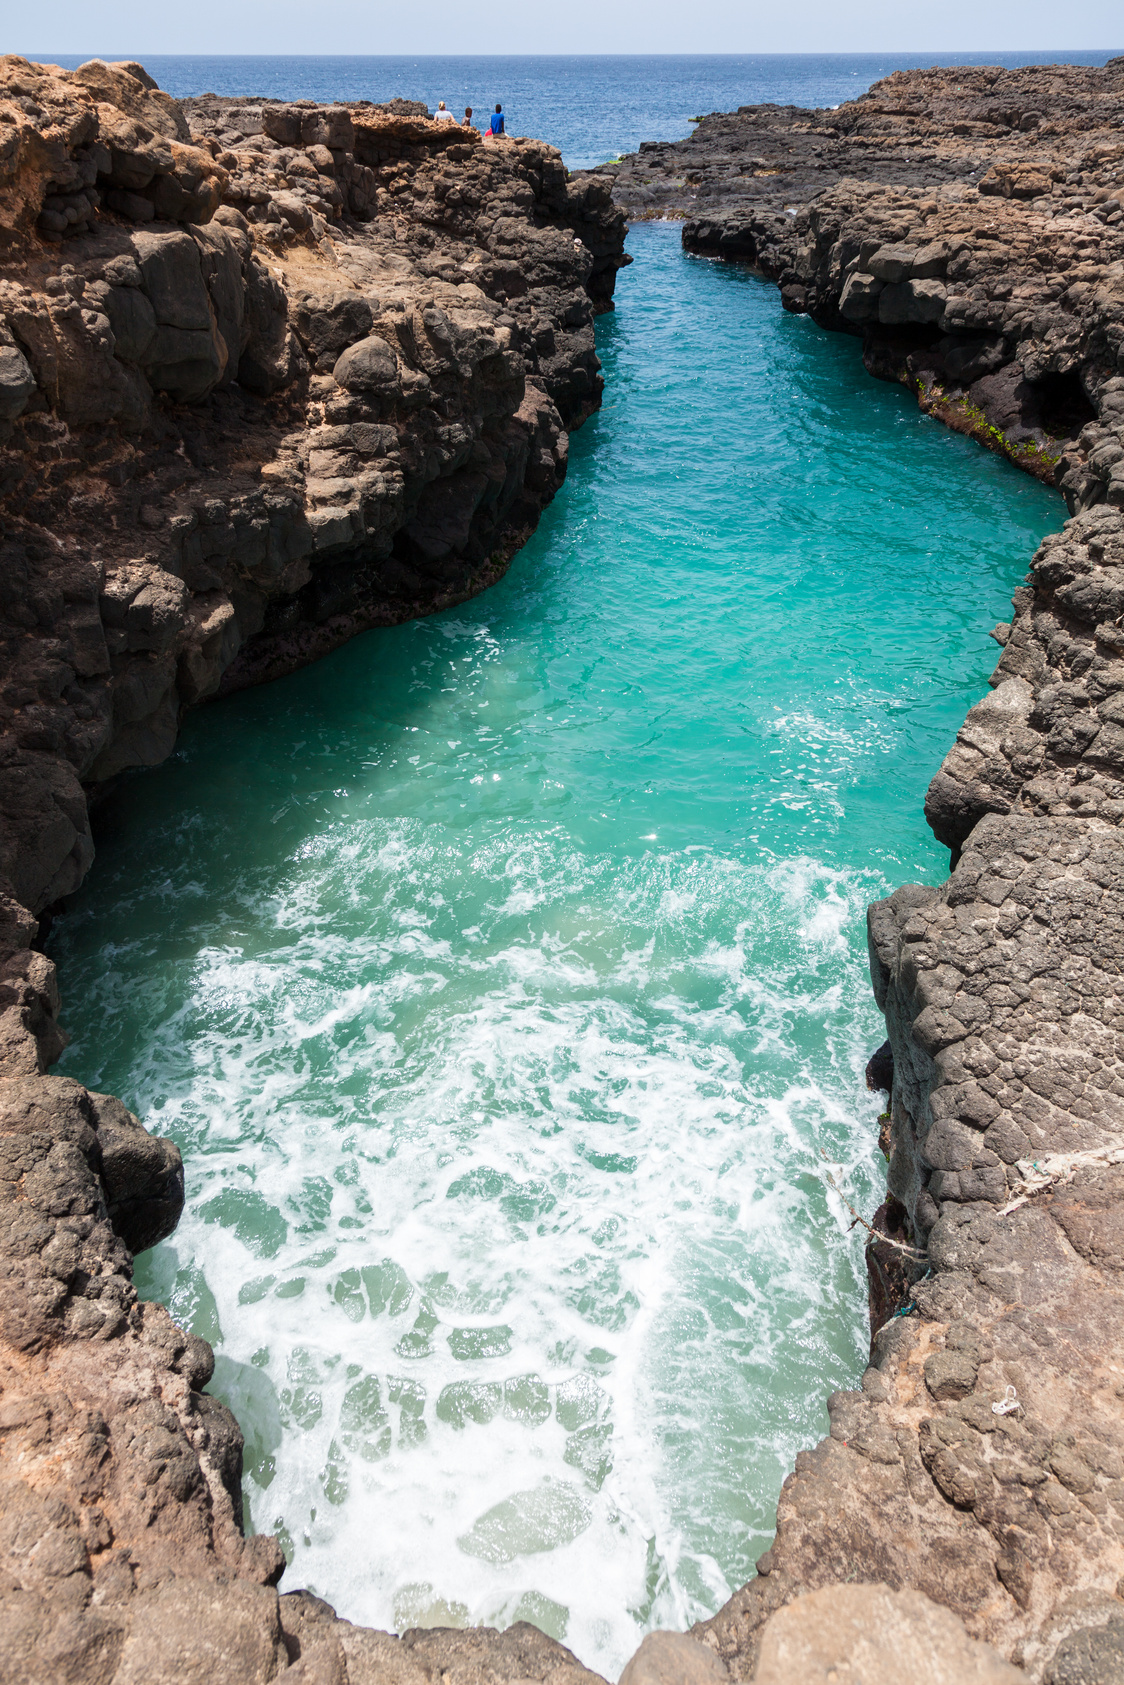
[{"x1": 603, "y1": 59, "x2": 1124, "y2": 488}]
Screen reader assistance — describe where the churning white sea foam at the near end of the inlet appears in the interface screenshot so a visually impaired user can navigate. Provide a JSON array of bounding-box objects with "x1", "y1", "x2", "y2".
[{"x1": 123, "y1": 835, "x2": 873, "y2": 1675}]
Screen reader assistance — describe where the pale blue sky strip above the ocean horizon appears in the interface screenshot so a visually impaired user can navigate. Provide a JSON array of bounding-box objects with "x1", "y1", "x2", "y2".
[{"x1": 22, "y1": 0, "x2": 1124, "y2": 57}]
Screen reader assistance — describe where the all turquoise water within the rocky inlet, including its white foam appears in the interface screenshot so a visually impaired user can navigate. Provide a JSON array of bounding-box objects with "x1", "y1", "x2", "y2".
[{"x1": 52, "y1": 226, "x2": 1063, "y2": 1675}]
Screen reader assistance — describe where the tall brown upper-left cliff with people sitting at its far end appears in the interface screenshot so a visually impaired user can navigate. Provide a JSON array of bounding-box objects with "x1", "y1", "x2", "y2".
[{"x1": 0, "y1": 59, "x2": 625, "y2": 923}]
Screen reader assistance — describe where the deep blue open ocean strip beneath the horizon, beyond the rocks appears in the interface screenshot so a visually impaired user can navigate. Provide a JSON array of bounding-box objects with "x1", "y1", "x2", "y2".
[{"x1": 32, "y1": 44, "x2": 1124, "y2": 169}]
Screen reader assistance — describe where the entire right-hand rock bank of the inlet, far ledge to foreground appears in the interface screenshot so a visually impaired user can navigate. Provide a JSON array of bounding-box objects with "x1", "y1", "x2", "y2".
[{"x1": 608, "y1": 59, "x2": 1124, "y2": 1685}]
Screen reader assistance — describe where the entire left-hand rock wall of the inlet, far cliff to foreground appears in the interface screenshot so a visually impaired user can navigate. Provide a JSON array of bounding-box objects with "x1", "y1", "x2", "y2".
[{"x1": 0, "y1": 57, "x2": 627, "y2": 1685}]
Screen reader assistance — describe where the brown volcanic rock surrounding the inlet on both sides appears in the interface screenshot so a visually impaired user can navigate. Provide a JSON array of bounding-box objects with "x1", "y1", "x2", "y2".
[{"x1": 0, "y1": 46, "x2": 1124, "y2": 1685}]
